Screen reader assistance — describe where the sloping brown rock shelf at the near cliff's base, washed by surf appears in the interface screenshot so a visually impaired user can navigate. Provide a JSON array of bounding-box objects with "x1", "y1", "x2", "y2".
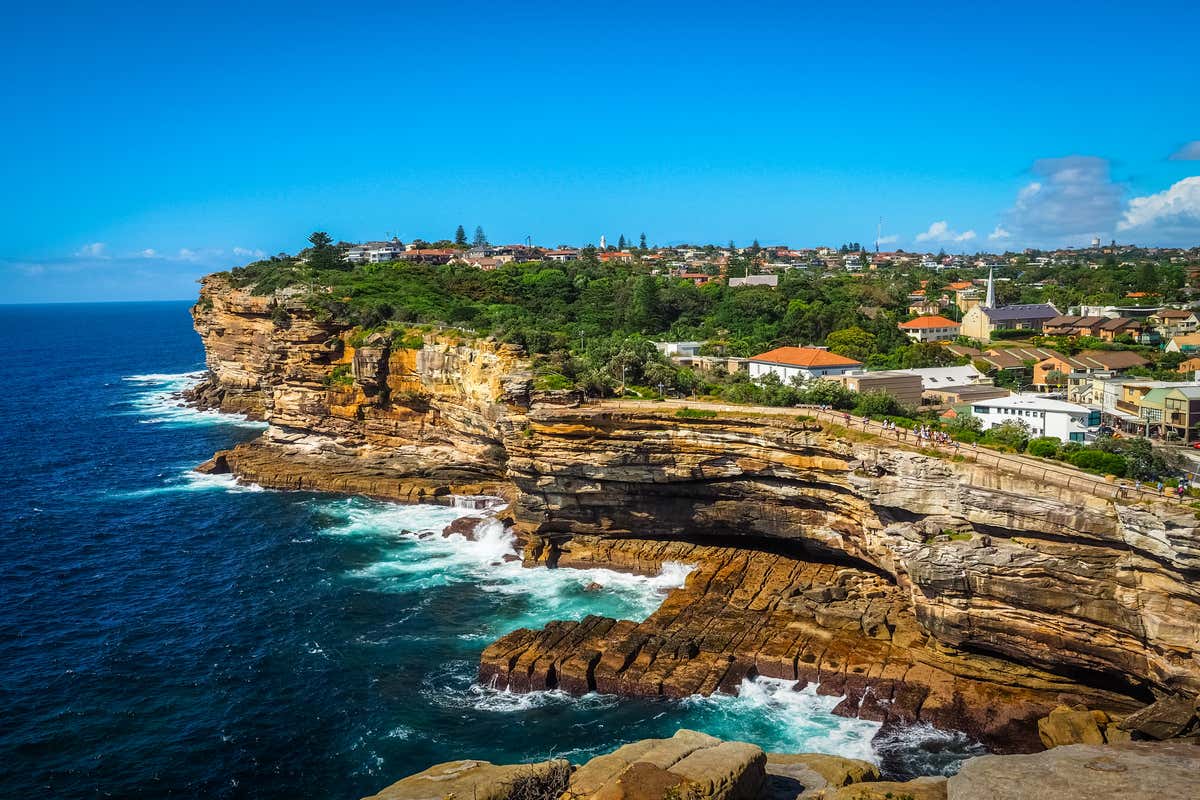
[{"x1": 480, "y1": 536, "x2": 1135, "y2": 750}]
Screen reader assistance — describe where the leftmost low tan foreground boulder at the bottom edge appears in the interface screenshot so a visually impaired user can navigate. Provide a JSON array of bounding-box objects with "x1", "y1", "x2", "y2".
[{"x1": 365, "y1": 759, "x2": 571, "y2": 800}]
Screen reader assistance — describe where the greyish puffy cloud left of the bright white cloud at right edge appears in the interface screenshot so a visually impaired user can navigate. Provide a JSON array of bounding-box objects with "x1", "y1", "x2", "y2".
[{"x1": 1002, "y1": 156, "x2": 1123, "y2": 245}]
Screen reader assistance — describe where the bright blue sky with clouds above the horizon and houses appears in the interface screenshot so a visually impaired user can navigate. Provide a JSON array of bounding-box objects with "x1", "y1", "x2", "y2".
[{"x1": 0, "y1": 1, "x2": 1200, "y2": 302}]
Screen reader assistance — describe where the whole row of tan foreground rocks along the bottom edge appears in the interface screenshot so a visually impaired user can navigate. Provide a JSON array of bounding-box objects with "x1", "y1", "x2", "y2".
[{"x1": 366, "y1": 730, "x2": 1200, "y2": 800}]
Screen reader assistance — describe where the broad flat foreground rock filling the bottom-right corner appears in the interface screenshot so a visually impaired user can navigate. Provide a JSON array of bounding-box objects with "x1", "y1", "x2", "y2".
[{"x1": 947, "y1": 741, "x2": 1200, "y2": 800}]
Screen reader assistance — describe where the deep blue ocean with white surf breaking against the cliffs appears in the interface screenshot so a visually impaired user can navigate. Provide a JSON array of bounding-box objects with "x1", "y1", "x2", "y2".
[{"x1": 0, "y1": 303, "x2": 972, "y2": 798}]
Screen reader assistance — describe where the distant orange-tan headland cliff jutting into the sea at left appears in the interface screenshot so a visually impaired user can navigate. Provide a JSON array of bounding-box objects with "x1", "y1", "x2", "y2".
[{"x1": 192, "y1": 276, "x2": 529, "y2": 499}]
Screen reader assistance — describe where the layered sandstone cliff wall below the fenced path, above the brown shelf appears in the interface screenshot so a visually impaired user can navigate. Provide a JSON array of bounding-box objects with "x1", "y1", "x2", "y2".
[{"x1": 506, "y1": 408, "x2": 1200, "y2": 694}]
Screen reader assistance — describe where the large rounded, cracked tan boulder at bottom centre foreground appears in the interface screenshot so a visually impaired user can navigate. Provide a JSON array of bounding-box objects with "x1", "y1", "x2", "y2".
[{"x1": 564, "y1": 730, "x2": 767, "y2": 800}]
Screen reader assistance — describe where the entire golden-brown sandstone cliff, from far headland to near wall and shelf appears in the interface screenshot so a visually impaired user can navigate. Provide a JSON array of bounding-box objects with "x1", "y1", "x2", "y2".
[{"x1": 187, "y1": 277, "x2": 1200, "y2": 748}]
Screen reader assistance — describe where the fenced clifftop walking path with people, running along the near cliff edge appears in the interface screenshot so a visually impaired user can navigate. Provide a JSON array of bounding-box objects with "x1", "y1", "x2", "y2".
[{"x1": 589, "y1": 399, "x2": 1190, "y2": 504}]
